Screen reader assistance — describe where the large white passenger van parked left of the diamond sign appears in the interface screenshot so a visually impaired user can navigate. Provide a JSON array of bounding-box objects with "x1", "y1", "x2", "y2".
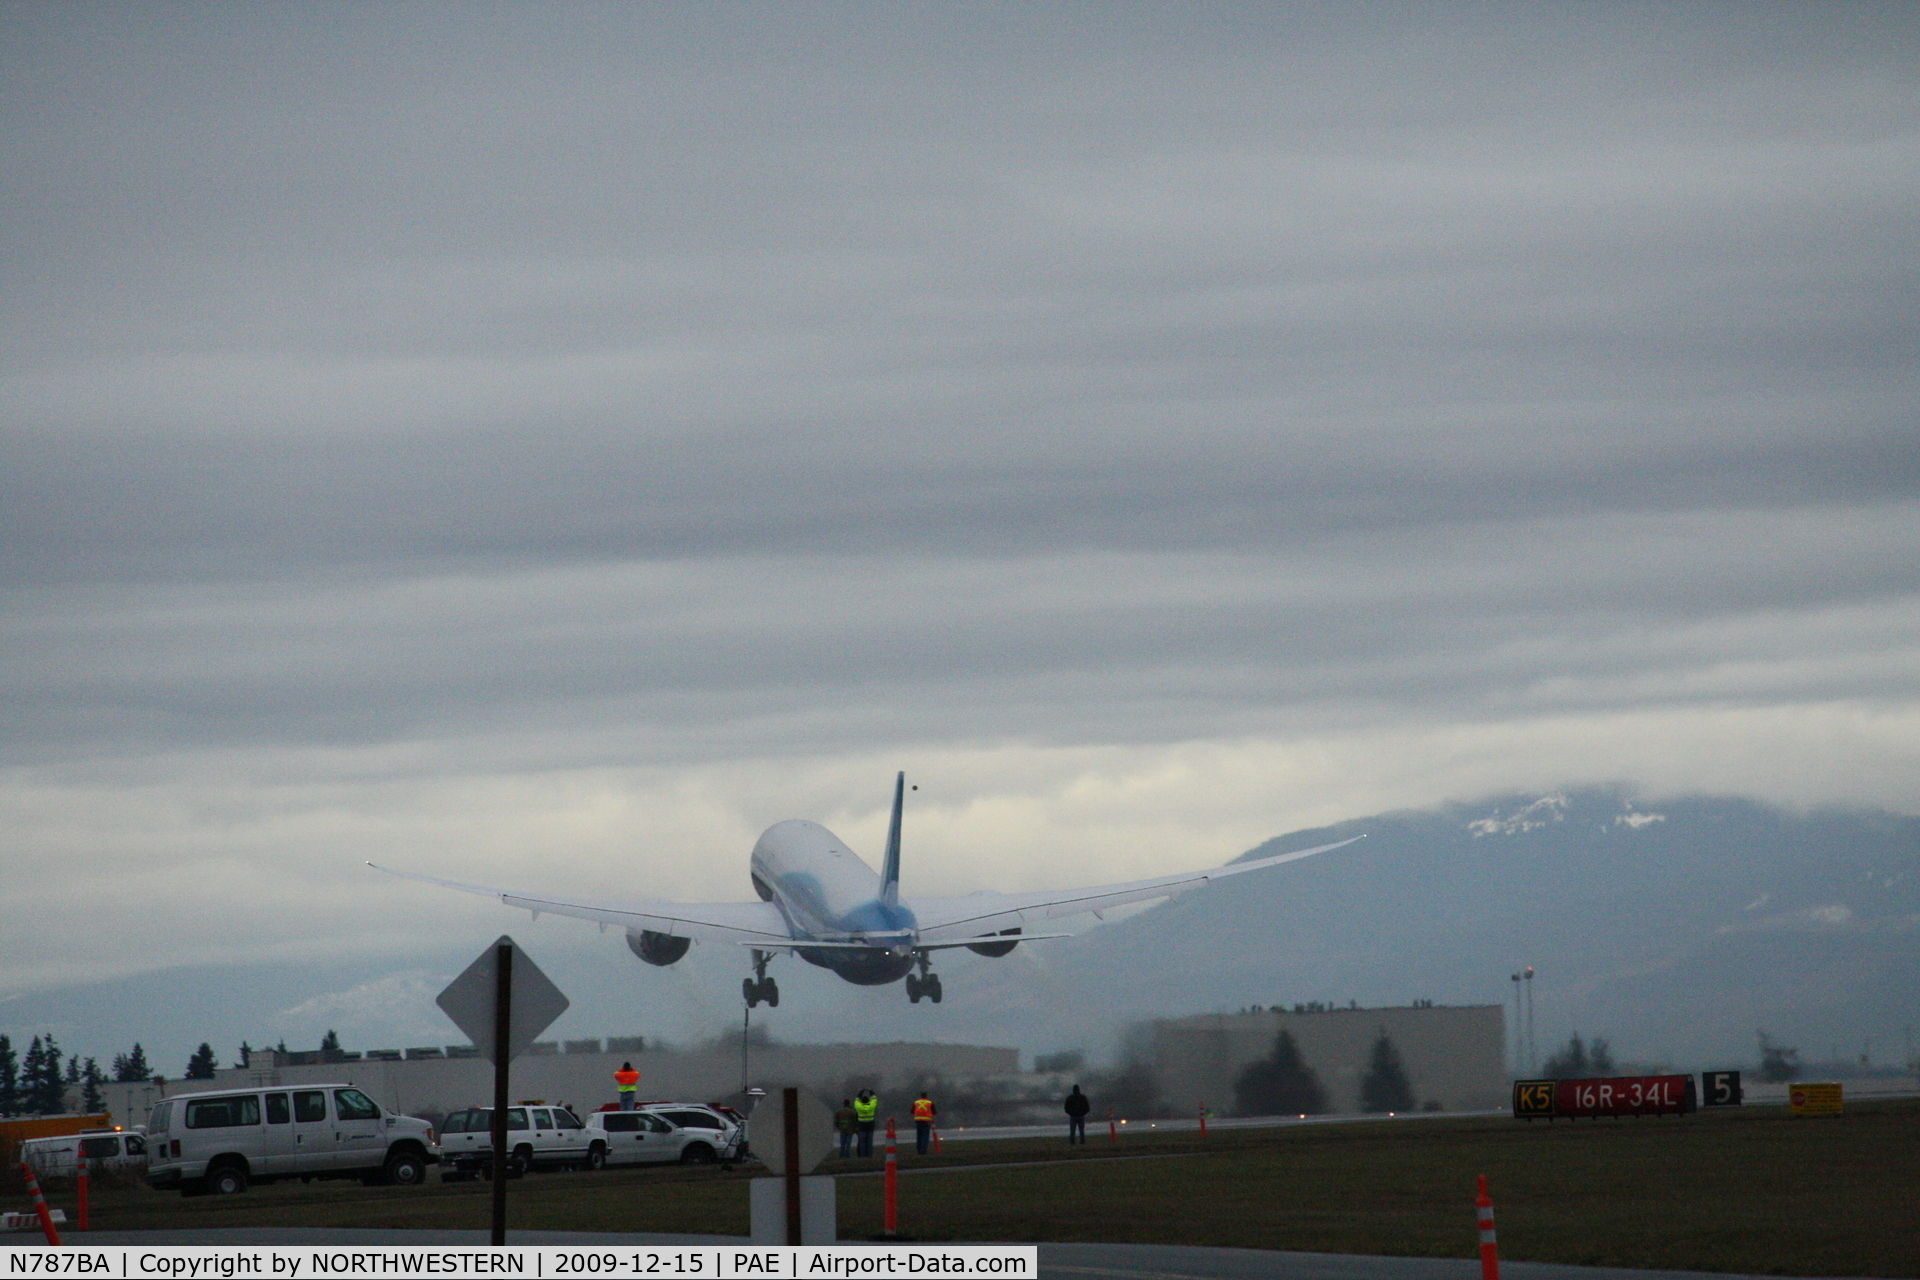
[{"x1": 146, "y1": 1084, "x2": 438, "y2": 1196}]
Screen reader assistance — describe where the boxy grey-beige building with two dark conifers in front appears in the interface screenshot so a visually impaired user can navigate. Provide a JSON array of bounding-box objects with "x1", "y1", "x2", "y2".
[{"x1": 1148, "y1": 1004, "x2": 1509, "y2": 1115}]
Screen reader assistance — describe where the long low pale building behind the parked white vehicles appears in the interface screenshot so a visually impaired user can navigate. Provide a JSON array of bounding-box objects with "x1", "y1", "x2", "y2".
[{"x1": 100, "y1": 1036, "x2": 1020, "y2": 1125}]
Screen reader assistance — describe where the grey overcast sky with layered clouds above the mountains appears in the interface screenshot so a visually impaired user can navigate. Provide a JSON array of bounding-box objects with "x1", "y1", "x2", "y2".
[{"x1": 0, "y1": 0, "x2": 1920, "y2": 1054}]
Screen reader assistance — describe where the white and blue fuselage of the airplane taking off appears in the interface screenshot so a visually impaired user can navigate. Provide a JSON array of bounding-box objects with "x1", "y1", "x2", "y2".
[{"x1": 751, "y1": 818, "x2": 918, "y2": 986}]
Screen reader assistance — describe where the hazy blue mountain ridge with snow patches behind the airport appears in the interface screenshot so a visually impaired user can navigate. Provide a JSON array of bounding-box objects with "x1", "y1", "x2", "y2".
[{"x1": 0, "y1": 787, "x2": 1920, "y2": 1075}]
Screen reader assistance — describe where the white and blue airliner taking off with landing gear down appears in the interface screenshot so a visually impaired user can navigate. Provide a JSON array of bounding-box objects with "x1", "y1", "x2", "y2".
[{"x1": 367, "y1": 773, "x2": 1361, "y2": 1009}]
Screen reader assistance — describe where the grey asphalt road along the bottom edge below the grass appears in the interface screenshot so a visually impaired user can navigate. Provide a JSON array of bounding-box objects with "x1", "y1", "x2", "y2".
[{"x1": 52, "y1": 1226, "x2": 1835, "y2": 1280}]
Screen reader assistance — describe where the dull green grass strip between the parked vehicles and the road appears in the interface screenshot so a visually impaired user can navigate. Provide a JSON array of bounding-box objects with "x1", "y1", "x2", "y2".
[{"x1": 67, "y1": 1102, "x2": 1920, "y2": 1276}]
